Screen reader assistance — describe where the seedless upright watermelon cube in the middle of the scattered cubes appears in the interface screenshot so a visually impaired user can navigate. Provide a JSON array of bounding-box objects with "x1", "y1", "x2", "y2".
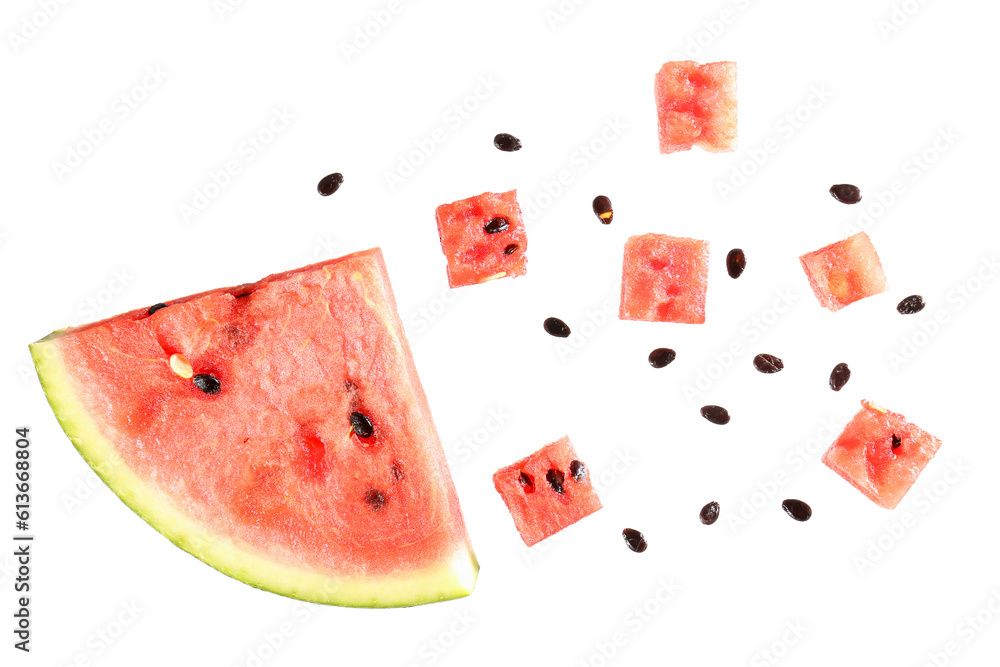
[{"x1": 618, "y1": 234, "x2": 708, "y2": 324}]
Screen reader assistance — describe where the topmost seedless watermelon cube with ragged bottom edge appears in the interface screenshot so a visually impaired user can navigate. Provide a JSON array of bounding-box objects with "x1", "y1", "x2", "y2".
[{"x1": 653, "y1": 60, "x2": 736, "y2": 153}]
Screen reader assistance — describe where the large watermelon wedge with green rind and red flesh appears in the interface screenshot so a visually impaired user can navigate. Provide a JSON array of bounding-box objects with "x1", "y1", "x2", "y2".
[{"x1": 31, "y1": 248, "x2": 479, "y2": 607}]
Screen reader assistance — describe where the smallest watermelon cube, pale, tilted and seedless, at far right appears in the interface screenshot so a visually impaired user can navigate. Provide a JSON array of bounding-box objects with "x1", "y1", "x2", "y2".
[{"x1": 799, "y1": 232, "x2": 889, "y2": 311}]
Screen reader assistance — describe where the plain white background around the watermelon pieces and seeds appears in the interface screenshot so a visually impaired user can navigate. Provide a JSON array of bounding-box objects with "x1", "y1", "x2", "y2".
[{"x1": 0, "y1": 0, "x2": 1000, "y2": 667}]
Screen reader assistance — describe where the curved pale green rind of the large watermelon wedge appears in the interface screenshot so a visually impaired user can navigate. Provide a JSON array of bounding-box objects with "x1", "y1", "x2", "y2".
[{"x1": 29, "y1": 331, "x2": 479, "y2": 607}]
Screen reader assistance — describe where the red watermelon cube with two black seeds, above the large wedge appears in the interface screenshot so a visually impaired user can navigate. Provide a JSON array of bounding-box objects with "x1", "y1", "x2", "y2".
[{"x1": 436, "y1": 190, "x2": 528, "y2": 287}]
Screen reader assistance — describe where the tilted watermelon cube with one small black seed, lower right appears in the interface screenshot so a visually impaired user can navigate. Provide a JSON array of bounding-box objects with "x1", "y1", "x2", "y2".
[{"x1": 823, "y1": 401, "x2": 941, "y2": 509}]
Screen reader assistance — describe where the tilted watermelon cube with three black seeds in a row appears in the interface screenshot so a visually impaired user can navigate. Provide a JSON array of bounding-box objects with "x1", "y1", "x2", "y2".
[{"x1": 493, "y1": 437, "x2": 601, "y2": 547}]
